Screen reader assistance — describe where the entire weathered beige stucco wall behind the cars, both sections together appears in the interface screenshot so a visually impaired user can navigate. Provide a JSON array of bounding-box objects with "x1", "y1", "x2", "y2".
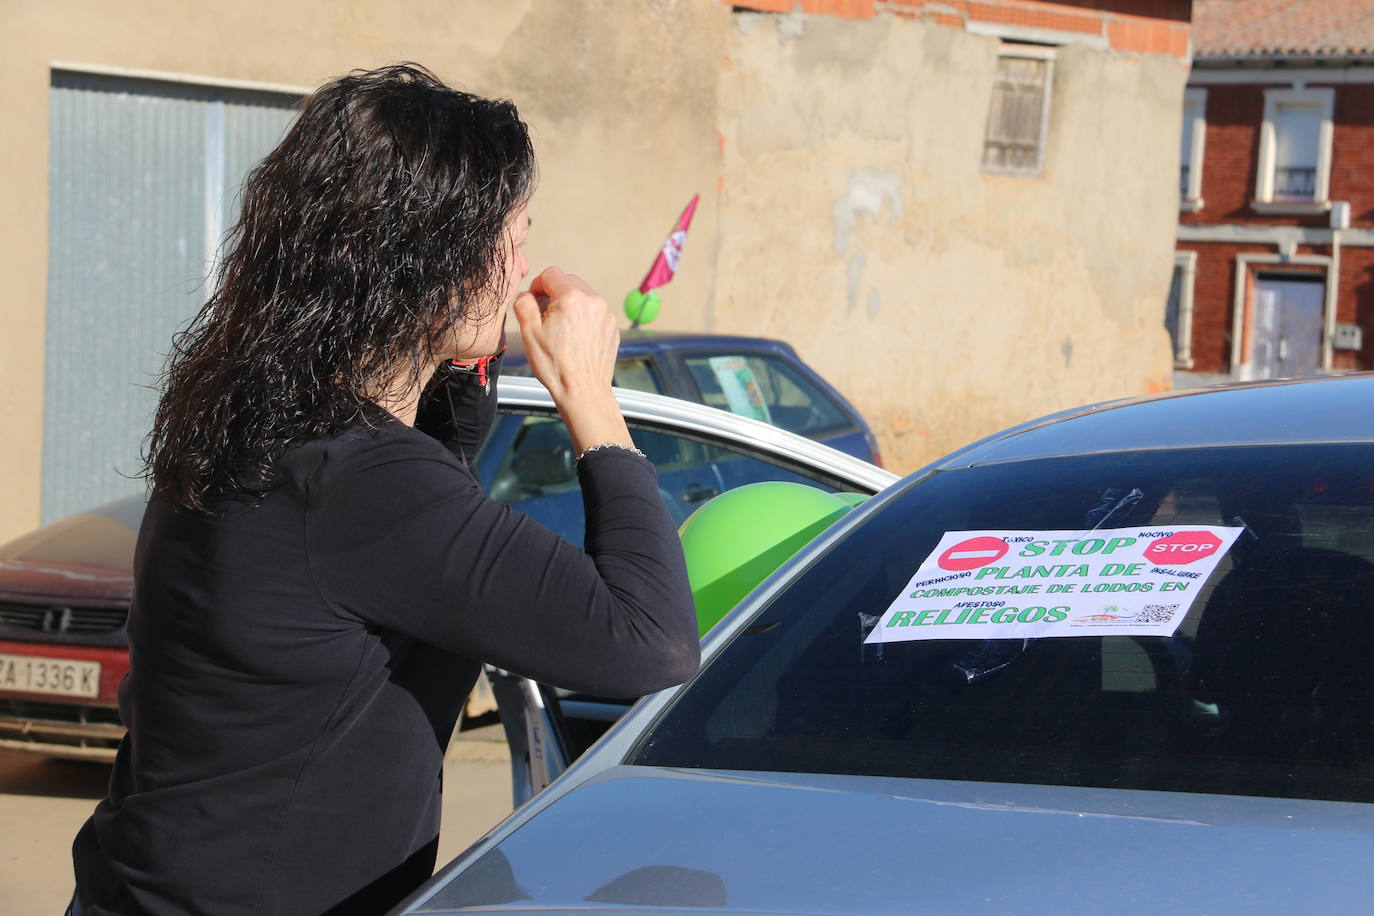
[{"x1": 0, "y1": 0, "x2": 1186, "y2": 540}]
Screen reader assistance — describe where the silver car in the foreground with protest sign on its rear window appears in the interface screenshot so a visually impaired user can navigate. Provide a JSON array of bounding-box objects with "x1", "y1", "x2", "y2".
[{"x1": 396, "y1": 375, "x2": 1374, "y2": 913}]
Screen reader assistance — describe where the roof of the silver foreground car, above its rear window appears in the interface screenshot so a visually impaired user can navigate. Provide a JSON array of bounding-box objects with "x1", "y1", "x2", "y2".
[{"x1": 925, "y1": 372, "x2": 1374, "y2": 471}]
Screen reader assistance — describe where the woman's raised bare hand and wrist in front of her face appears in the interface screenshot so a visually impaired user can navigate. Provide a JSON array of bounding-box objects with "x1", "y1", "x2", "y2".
[{"x1": 514, "y1": 268, "x2": 633, "y2": 455}]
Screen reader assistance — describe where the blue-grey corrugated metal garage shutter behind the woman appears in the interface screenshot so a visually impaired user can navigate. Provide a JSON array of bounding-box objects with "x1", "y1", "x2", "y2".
[{"x1": 43, "y1": 73, "x2": 298, "y2": 522}]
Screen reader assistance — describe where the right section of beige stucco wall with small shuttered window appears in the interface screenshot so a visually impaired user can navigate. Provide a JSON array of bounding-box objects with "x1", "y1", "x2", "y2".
[{"x1": 713, "y1": 14, "x2": 1187, "y2": 471}]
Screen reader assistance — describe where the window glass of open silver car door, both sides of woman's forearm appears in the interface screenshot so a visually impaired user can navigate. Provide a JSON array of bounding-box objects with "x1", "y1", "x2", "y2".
[{"x1": 478, "y1": 416, "x2": 838, "y2": 544}]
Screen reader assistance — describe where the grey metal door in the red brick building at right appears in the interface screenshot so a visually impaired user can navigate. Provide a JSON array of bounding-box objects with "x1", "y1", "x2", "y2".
[{"x1": 1250, "y1": 275, "x2": 1326, "y2": 379}]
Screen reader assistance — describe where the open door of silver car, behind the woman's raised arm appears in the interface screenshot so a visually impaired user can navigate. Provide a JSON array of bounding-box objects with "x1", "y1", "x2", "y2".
[{"x1": 469, "y1": 378, "x2": 897, "y2": 805}]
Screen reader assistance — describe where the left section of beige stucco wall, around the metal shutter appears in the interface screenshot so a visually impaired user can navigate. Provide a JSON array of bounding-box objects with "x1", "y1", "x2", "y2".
[{"x1": 0, "y1": 0, "x2": 730, "y2": 540}]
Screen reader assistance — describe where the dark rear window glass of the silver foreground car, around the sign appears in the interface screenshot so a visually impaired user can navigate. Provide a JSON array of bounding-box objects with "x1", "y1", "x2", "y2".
[{"x1": 627, "y1": 445, "x2": 1374, "y2": 802}]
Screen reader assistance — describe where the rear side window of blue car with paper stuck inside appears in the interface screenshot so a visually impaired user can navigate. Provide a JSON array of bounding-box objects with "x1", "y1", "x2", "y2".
[{"x1": 683, "y1": 354, "x2": 851, "y2": 435}]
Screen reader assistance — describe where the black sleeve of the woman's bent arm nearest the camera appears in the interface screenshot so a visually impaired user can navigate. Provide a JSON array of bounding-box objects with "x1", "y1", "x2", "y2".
[{"x1": 305, "y1": 368, "x2": 699, "y2": 696}]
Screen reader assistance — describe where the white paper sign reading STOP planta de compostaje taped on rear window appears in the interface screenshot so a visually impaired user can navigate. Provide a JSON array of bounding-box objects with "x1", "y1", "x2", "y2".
[{"x1": 864, "y1": 525, "x2": 1245, "y2": 643}]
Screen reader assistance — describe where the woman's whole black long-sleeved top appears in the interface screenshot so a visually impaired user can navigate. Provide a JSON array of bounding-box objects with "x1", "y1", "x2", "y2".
[{"x1": 73, "y1": 372, "x2": 698, "y2": 916}]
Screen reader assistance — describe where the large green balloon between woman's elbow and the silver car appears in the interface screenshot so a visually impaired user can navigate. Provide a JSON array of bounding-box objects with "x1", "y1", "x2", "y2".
[{"x1": 677, "y1": 481, "x2": 867, "y2": 634}]
